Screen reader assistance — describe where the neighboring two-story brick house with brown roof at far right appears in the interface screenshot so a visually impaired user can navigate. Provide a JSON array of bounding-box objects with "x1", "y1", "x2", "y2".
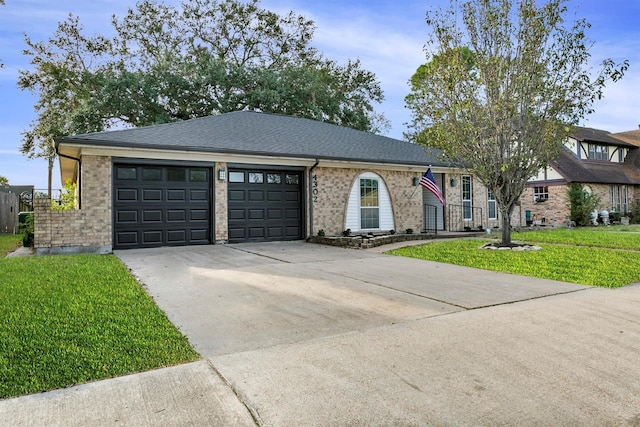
[{"x1": 520, "y1": 127, "x2": 640, "y2": 226}]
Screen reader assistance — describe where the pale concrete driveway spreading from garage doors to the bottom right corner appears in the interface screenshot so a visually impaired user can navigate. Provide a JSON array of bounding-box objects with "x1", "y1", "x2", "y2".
[{"x1": 111, "y1": 242, "x2": 640, "y2": 426}]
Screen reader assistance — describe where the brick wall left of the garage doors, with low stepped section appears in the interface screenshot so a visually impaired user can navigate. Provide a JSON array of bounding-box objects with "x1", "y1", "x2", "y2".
[{"x1": 34, "y1": 156, "x2": 112, "y2": 253}]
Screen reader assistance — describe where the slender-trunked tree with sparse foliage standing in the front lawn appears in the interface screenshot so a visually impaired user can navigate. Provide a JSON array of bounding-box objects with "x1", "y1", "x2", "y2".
[{"x1": 406, "y1": 0, "x2": 628, "y2": 245}]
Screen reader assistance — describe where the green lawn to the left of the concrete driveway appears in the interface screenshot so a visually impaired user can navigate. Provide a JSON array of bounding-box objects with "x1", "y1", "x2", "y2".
[{"x1": 0, "y1": 255, "x2": 199, "y2": 398}]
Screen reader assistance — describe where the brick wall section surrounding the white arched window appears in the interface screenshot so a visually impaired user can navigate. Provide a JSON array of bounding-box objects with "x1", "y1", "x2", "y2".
[{"x1": 308, "y1": 167, "x2": 422, "y2": 235}]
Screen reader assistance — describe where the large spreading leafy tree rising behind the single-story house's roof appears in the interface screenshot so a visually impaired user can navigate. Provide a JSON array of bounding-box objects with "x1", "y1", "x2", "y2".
[{"x1": 18, "y1": 0, "x2": 387, "y2": 196}]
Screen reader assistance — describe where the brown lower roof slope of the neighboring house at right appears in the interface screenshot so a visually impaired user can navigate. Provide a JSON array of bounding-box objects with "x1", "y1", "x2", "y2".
[{"x1": 551, "y1": 147, "x2": 640, "y2": 185}]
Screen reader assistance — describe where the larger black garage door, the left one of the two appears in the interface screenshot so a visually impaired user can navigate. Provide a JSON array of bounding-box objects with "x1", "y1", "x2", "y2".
[{"x1": 113, "y1": 164, "x2": 211, "y2": 249}]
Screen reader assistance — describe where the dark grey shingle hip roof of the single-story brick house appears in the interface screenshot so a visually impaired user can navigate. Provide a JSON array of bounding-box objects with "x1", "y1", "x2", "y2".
[{"x1": 56, "y1": 111, "x2": 448, "y2": 166}]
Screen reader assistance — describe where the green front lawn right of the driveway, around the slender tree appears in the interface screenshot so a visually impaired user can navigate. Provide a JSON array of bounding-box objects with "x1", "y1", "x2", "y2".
[{"x1": 388, "y1": 229, "x2": 640, "y2": 288}]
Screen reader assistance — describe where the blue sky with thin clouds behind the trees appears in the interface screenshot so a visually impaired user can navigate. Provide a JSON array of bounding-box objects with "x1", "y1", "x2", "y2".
[{"x1": 0, "y1": 0, "x2": 640, "y2": 189}]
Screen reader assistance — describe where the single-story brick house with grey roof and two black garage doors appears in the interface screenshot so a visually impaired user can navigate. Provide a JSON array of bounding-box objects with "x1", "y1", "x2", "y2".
[{"x1": 34, "y1": 111, "x2": 508, "y2": 253}]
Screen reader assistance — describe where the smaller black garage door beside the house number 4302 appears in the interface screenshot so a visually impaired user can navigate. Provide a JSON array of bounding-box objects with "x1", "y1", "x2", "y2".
[{"x1": 228, "y1": 168, "x2": 303, "y2": 243}]
